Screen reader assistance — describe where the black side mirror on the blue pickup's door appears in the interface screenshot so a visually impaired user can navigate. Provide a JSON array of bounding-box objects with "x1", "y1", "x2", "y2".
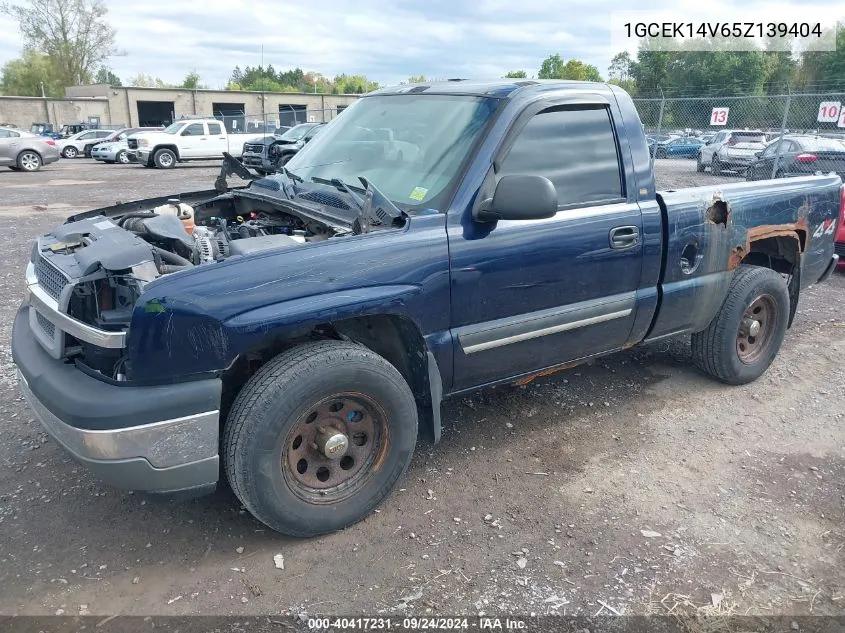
[{"x1": 473, "y1": 176, "x2": 557, "y2": 222}]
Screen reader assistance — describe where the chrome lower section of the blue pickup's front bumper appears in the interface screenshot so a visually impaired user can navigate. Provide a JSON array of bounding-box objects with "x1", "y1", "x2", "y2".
[{"x1": 17, "y1": 370, "x2": 220, "y2": 468}]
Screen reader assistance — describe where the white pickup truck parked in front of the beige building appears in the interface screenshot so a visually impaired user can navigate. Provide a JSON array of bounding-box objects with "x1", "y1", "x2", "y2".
[{"x1": 127, "y1": 119, "x2": 264, "y2": 169}]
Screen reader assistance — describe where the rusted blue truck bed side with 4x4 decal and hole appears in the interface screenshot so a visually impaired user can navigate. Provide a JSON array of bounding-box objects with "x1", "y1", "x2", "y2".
[{"x1": 647, "y1": 175, "x2": 841, "y2": 340}]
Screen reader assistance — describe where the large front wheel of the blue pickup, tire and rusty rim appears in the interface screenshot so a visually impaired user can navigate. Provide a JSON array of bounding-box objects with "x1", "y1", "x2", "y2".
[{"x1": 223, "y1": 341, "x2": 417, "y2": 537}]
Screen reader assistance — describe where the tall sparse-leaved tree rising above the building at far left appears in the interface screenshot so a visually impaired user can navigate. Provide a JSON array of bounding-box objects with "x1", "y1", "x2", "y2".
[{"x1": 2, "y1": 0, "x2": 115, "y2": 86}]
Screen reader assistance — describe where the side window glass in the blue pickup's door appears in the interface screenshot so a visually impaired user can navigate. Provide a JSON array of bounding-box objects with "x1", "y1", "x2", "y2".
[{"x1": 496, "y1": 108, "x2": 624, "y2": 206}]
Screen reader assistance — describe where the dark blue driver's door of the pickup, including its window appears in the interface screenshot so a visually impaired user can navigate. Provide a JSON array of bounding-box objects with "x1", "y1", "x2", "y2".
[{"x1": 448, "y1": 102, "x2": 643, "y2": 390}]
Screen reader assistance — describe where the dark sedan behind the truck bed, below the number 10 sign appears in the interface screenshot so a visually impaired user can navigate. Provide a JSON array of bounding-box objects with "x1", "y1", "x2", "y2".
[{"x1": 745, "y1": 135, "x2": 845, "y2": 180}]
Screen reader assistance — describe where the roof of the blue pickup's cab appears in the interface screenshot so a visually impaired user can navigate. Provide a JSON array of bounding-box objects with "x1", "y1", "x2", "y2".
[{"x1": 367, "y1": 79, "x2": 611, "y2": 99}]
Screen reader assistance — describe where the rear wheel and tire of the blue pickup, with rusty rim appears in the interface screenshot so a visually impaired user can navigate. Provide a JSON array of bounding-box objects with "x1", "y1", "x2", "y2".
[{"x1": 692, "y1": 265, "x2": 790, "y2": 385}]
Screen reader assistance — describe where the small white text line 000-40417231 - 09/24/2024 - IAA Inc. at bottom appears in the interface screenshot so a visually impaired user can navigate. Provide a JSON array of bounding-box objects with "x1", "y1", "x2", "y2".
[{"x1": 308, "y1": 616, "x2": 527, "y2": 631}]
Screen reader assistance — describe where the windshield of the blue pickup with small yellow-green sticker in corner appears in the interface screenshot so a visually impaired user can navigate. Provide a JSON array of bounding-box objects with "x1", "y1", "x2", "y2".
[{"x1": 288, "y1": 94, "x2": 499, "y2": 209}]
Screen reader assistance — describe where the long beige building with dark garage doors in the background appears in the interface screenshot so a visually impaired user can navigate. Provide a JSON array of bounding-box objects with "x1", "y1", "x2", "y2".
[{"x1": 0, "y1": 84, "x2": 358, "y2": 131}]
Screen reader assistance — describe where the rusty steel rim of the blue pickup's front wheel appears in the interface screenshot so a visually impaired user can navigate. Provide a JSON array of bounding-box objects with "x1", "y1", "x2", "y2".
[{"x1": 281, "y1": 392, "x2": 390, "y2": 504}]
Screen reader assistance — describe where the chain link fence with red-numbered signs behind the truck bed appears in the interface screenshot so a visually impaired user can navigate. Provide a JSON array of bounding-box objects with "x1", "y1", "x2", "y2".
[{"x1": 634, "y1": 92, "x2": 845, "y2": 180}]
